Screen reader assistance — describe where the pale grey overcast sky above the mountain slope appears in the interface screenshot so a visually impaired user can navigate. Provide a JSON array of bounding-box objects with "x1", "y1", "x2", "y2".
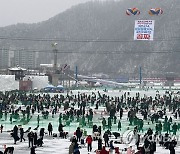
[{"x1": 0, "y1": 0, "x2": 91, "y2": 27}]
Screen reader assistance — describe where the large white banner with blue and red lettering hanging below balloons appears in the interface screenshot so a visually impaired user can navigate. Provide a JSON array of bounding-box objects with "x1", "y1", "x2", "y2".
[{"x1": 134, "y1": 20, "x2": 154, "y2": 40}]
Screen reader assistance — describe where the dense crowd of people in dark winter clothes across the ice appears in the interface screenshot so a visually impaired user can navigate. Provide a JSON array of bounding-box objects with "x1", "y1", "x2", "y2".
[{"x1": 0, "y1": 91, "x2": 180, "y2": 154}]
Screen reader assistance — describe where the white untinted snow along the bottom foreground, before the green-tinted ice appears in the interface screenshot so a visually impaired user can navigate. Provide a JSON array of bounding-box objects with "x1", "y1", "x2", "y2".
[{"x1": 0, "y1": 132, "x2": 180, "y2": 154}]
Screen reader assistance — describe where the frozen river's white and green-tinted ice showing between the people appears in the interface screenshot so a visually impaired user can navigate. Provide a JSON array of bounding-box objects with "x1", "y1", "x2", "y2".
[{"x1": 0, "y1": 90, "x2": 180, "y2": 154}]
